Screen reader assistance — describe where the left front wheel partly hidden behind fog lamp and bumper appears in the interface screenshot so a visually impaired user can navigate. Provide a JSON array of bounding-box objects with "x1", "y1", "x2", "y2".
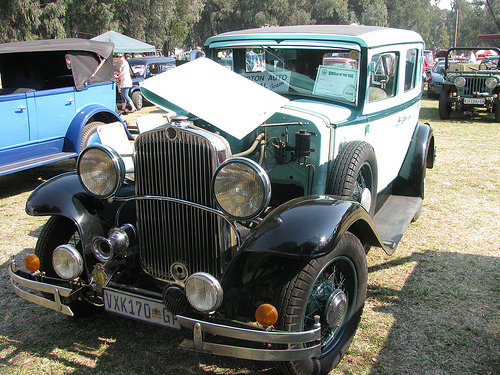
[{"x1": 35, "y1": 216, "x2": 101, "y2": 317}]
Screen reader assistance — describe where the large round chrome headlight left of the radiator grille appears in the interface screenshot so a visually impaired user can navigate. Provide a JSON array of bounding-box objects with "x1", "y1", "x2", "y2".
[{"x1": 77, "y1": 144, "x2": 125, "y2": 198}]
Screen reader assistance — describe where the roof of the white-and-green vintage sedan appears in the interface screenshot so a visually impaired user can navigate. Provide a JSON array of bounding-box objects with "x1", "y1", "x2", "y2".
[{"x1": 205, "y1": 25, "x2": 423, "y2": 47}]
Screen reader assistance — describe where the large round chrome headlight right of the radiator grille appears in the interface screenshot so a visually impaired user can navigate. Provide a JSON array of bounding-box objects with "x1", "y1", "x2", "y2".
[{"x1": 213, "y1": 157, "x2": 271, "y2": 220}]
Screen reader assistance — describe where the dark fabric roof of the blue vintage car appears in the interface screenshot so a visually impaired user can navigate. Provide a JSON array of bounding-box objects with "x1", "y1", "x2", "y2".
[{"x1": 0, "y1": 38, "x2": 114, "y2": 59}]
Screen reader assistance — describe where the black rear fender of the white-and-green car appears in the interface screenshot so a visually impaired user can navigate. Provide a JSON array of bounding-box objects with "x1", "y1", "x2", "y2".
[{"x1": 393, "y1": 123, "x2": 436, "y2": 199}]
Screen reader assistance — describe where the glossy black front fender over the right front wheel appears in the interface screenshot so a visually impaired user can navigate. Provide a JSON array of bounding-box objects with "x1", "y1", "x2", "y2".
[{"x1": 221, "y1": 195, "x2": 385, "y2": 319}]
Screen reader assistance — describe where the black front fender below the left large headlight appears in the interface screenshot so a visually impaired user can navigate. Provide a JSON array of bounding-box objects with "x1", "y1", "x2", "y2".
[{"x1": 26, "y1": 172, "x2": 135, "y2": 254}]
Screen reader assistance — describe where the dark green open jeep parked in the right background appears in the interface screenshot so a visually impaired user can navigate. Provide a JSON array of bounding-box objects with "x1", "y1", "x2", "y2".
[{"x1": 439, "y1": 47, "x2": 500, "y2": 122}]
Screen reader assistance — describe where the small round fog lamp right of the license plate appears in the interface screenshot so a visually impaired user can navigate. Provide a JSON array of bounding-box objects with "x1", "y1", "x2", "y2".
[{"x1": 185, "y1": 272, "x2": 223, "y2": 312}]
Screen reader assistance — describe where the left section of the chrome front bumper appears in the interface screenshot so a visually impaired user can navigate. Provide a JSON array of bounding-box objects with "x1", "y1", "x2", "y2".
[{"x1": 9, "y1": 259, "x2": 74, "y2": 316}]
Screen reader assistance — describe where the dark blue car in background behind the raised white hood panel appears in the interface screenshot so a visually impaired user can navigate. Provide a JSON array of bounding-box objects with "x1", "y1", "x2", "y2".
[{"x1": 119, "y1": 56, "x2": 176, "y2": 109}]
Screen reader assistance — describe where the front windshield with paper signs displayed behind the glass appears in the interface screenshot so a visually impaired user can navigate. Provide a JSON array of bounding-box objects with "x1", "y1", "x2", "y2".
[{"x1": 211, "y1": 47, "x2": 360, "y2": 104}]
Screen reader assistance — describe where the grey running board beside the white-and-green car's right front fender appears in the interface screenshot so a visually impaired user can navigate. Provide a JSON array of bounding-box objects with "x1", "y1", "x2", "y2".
[{"x1": 373, "y1": 195, "x2": 422, "y2": 252}]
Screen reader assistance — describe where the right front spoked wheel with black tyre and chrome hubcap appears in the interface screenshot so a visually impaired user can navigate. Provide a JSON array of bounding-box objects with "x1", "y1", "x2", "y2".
[{"x1": 278, "y1": 232, "x2": 368, "y2": 375}]
